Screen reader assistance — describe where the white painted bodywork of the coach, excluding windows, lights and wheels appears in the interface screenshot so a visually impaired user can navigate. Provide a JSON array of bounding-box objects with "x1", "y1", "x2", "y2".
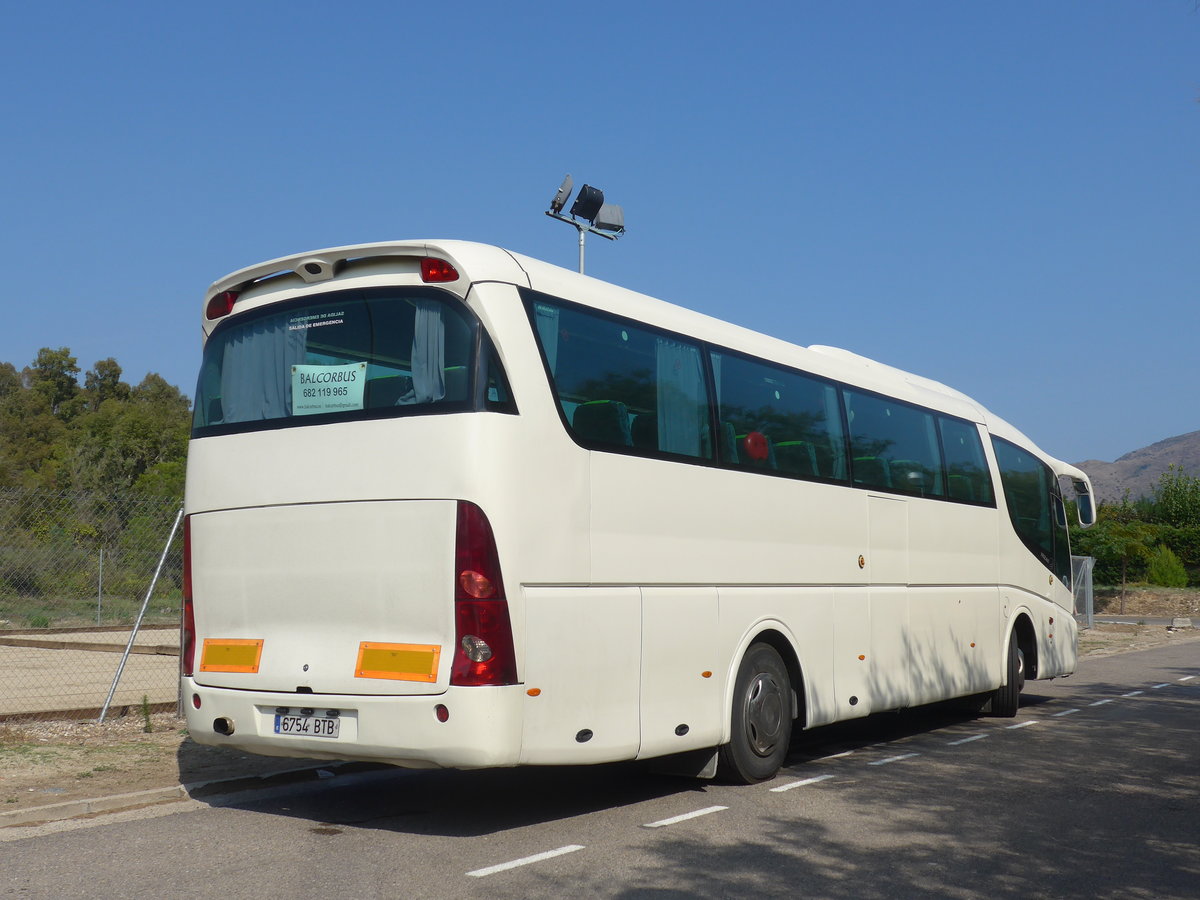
[{"x1": 185, "y1": 241, "x2": 1081, "y2": 767}]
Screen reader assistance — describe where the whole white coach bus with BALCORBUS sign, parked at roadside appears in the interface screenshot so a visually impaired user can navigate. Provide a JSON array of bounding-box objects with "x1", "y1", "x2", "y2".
[{"x1": 182, "y1": 241, "x2": 1093, "y2": 782}]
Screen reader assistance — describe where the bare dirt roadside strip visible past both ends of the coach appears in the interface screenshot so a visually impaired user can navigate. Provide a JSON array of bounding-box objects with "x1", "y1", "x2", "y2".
[{"x1": 0, "y1": 600, "x2": 1200, "y2": 826}]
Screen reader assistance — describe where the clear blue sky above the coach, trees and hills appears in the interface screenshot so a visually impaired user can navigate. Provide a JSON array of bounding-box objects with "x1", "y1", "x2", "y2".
[{"x1": 0, "y1": 0, "x2": 1200, "y2": 461}]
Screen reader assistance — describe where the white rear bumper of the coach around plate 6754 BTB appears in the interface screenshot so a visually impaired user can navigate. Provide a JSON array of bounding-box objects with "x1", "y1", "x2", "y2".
[{"x1": 182, "y1": 678, "x2": 523, "y2": 768}]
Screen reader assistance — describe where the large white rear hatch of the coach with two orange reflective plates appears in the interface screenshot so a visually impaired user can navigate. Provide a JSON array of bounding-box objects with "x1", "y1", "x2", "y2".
[{"x1": 190, "y1": 500, "x2": 456, "y2": 695}]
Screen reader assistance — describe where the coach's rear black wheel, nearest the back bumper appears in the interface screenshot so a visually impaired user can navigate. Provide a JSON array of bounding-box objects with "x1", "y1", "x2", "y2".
[{"x1": 718, "y1": 643, "x2": 792, "y2": 785}]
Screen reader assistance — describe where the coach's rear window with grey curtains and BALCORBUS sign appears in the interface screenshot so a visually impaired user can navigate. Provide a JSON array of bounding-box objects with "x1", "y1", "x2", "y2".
[{"x1": 193, "y1": 288, "x2": 510, "y2": 437}]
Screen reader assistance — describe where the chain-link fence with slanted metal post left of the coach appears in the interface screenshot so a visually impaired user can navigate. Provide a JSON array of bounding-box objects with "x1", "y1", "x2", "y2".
[{"x1": 0, "y1": 490, "x2": 182, "y2": 719}]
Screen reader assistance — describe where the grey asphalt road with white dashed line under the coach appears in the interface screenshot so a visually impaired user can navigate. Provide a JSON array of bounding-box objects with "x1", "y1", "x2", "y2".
[{"x1": 0, "y1": 642, "x2": 1200, "y2": 900}]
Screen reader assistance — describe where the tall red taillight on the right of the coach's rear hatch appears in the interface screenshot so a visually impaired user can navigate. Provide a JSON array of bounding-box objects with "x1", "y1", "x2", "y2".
[{"x1": 450, "y1": 500, "x2": 517, "y2": 685}]
